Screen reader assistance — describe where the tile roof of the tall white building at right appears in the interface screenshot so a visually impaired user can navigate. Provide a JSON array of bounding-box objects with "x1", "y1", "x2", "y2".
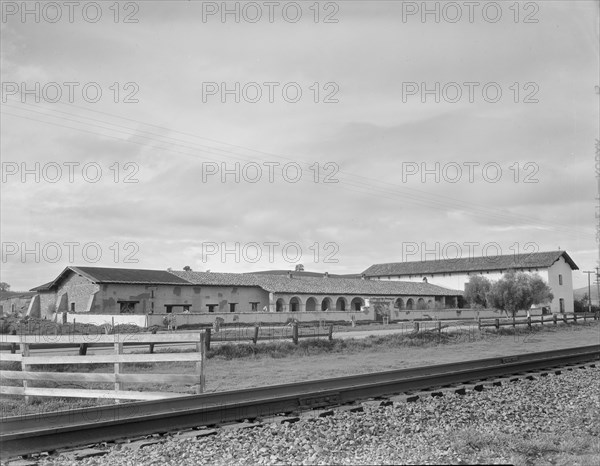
[{"x1": 363, "y1": 251, "x2": 579, "y2": 277}]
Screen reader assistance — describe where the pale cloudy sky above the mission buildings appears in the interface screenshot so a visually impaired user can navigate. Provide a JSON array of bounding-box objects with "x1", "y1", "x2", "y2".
[{"x1": 1, "y1": 0, "x2": 600, "y2": 290}]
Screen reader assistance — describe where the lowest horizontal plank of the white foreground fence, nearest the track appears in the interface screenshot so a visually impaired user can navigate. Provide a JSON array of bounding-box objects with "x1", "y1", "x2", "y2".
[{"x1": 0, "y1": 386, "x2": 190, "y2": 400}]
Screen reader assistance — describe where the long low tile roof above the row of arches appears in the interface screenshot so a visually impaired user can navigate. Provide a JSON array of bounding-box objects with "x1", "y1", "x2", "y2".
[{"x1": 173, "y1": 271, "x2": 462, "y2": 296}]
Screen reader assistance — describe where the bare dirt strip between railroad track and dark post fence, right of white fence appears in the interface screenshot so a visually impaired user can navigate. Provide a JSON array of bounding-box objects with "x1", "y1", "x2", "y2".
[{"x1": 205, "y1": 323, "x2": 600, "y2": 392}]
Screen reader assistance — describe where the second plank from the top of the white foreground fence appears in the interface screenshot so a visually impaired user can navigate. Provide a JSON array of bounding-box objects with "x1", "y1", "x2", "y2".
[{"x1": 23, "y1": 352, "x2": 202, "y2": 365}]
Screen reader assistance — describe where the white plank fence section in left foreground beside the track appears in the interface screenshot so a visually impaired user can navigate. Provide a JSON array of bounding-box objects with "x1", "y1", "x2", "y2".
[{"x1": 0, "y1": 332, "x2": 206, "y2": 402}]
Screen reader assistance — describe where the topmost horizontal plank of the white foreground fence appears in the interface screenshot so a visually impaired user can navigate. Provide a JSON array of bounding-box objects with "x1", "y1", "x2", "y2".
[{"x1": 0, "y1": 332, "x2": 202, "y2": 345}]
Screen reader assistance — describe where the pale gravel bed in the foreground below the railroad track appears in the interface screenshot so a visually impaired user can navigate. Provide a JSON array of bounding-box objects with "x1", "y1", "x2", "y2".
[{"x1": 28, "y1": 367, "x2": 600, "y2": 466}]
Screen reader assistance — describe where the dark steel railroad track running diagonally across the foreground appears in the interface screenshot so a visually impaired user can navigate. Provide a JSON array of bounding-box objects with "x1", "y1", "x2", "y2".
[{"x1": 0, "y1": 345, "x2": 600, "y2": 460}]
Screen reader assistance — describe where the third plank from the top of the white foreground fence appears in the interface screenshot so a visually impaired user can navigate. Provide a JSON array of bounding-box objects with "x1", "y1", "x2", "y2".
[{"x1": 0, "y1": 371, "x2": 198, "y2": 384}]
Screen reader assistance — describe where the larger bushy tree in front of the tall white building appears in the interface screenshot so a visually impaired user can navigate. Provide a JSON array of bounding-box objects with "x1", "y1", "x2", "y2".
[{"x1": 486, "y1": 270, "x2": 554, "y2": 318}]
